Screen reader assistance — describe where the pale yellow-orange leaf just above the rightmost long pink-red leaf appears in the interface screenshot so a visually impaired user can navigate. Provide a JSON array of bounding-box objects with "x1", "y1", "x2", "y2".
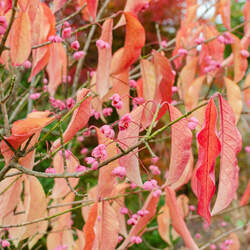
[{"x1": 224, "y1": 77, "x2": 243, "y2": 124}]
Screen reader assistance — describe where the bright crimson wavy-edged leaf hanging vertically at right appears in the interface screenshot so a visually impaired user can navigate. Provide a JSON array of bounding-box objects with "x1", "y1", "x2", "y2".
[{"x1": 192, "y1": 99, "x2": 220, "y2": 223}]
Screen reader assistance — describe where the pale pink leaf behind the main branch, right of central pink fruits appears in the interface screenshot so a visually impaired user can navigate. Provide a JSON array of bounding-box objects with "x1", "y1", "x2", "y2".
[{"x1": 117, "y1": 106, "x2": 144, "y2": 186}]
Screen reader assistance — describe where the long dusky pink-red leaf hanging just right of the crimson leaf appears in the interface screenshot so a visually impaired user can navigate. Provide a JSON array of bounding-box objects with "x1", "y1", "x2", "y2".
[{"x1": 212, "y1": 95, "x2": 242, "y2": 214}]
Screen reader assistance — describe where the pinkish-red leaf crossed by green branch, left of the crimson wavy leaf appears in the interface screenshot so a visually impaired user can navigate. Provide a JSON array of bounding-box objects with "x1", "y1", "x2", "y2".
[{"x1": 166, "y1": 104, "x2": 192, "y2": 185}]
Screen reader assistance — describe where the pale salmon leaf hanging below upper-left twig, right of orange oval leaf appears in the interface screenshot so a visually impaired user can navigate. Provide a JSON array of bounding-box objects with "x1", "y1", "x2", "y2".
[{"x1": 47, "y1": 43, "x2": 67, "y2": 96}]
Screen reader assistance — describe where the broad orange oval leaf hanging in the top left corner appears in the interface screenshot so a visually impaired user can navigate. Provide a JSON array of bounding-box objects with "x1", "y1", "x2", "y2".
[{"x1": 10, "y1": 11, "x2": 31, "y2": 65}]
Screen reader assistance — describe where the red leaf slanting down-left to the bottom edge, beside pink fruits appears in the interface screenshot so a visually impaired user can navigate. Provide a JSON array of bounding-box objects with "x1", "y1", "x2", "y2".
[{"x1": 118, "y1": 193, "x2": 159, "y2": 250}]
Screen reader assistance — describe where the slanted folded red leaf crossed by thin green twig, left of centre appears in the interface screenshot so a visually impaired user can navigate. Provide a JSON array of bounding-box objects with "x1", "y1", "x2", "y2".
[{"x1": 52, "y1": 89, "x2": 91, "y2": 150}]
